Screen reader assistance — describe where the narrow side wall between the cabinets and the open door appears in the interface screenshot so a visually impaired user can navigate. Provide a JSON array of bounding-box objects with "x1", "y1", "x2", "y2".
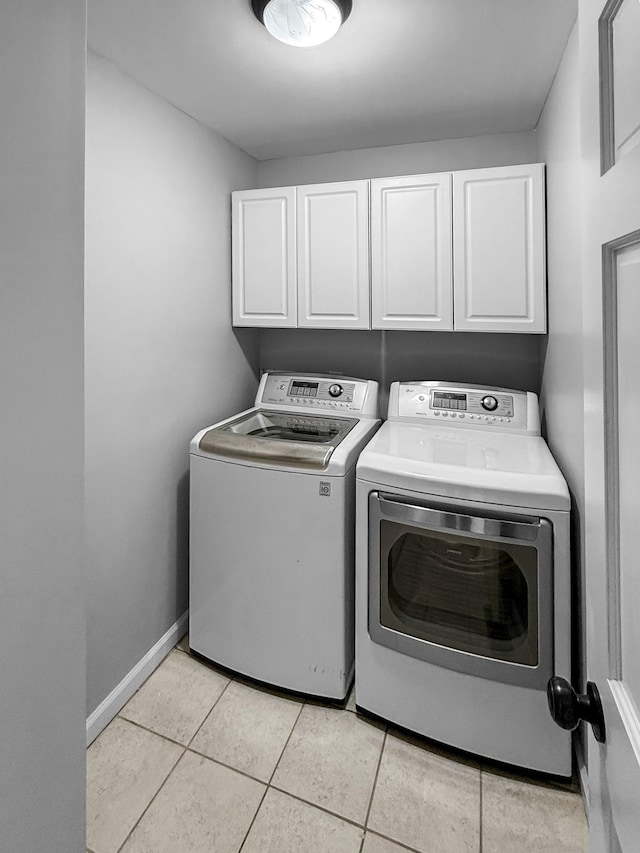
[{"x1": 538, "y1": 24, "x2": 585, "y2": 700}]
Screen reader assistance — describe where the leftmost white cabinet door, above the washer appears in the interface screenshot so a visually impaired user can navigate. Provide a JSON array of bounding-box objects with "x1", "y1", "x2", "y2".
[{"x1": 231, "y1": 187, "x2": 297, "y2": 328}]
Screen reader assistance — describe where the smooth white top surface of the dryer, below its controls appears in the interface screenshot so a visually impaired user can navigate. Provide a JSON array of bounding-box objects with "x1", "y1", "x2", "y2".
[{"x1": 357, "y1": 421, "x2": 571, "y2": 510}]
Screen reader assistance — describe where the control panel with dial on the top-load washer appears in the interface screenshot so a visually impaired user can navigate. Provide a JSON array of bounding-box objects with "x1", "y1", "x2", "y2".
[{"x1": 256, "y1": 373, "x2": 378, "y2": 417}]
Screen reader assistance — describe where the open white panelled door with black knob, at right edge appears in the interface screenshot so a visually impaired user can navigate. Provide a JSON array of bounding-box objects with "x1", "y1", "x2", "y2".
[{"x1": 579, "y1": 0, "x2": 640, "y2": 853}]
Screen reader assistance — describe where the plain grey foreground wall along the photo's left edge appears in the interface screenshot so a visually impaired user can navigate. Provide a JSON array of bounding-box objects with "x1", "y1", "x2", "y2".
[{"x1": 0, "y1": 0, "x2": 85, "y2": 853}]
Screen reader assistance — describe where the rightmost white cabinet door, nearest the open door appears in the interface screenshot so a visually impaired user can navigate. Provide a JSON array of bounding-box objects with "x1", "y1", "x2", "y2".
[{"x1": 453, "y1": 164, "x2": 546, "y2": 332}]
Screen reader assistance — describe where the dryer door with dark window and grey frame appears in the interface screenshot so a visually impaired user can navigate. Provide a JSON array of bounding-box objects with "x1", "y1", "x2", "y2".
[{"x1": 369, "y1": 492, "x2": 553, "y2": 688}]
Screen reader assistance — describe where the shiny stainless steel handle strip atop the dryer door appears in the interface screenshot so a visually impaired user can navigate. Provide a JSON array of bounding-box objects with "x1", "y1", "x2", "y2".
[{"x1": 378, "y1": 494, "x2": 540, "y2": 542}]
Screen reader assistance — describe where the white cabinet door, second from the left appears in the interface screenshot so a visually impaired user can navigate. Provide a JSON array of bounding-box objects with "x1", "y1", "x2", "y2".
[{"x1": 296, "y1": 181, "x2": 370, "y2": 329}]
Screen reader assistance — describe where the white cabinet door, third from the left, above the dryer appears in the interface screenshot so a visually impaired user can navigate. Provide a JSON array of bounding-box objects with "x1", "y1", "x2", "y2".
[{"x1": 371, "y1": 173, "x2": 453, "y2": 330}]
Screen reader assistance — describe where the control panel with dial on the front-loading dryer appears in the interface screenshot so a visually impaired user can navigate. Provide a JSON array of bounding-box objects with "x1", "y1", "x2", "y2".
[{"x1": 388, "y1": 382, "x2": 540, "y2": 435}]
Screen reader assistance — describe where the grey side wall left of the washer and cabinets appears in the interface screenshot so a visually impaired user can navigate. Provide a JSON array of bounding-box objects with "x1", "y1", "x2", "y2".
[{"x1": 86, "y1": 54, "x2": 257, "y2": 712}]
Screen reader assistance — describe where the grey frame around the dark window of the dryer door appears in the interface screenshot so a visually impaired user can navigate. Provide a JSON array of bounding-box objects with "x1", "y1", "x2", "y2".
[{"x1": 368, "y1": 492, "x2": 553, "y2": 689}]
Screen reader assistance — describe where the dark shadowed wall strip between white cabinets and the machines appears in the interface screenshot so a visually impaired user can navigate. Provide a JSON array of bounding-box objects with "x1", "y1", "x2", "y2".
[{"x1": 259, "y1": 329, "x2": 541, "y2": 412}]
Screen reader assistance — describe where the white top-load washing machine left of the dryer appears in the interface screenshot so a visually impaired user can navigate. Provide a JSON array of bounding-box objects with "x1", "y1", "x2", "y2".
[{"x1": 189, "y1": 373, "x2": 380, "y2": 700}]
